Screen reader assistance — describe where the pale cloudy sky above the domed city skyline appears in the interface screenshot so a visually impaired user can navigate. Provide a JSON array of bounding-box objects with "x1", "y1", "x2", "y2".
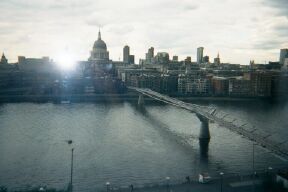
[{"x1": 0, "y1": 0, "x2": 288, "y2": 64}]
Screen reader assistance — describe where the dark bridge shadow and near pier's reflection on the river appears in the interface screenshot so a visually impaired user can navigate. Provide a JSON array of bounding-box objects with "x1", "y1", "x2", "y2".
[{"x1": 133, "y1": 105, "x2": 210, "y2": 171}]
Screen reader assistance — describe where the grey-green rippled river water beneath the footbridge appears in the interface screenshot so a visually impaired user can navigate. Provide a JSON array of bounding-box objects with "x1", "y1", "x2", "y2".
[{"x1": 0, "y1": 101, "x2": 288, "y2": 191}]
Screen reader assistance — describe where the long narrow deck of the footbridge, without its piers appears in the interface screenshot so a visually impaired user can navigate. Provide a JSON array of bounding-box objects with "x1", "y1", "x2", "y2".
[{"x1": 128, "y1": 87, "x2": 288, "y2": 159}]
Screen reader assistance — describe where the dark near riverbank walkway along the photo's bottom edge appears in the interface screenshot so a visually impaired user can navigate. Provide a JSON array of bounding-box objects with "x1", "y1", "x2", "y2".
[{"x1": 0, "y1": 172, "x2": 287, "y2": 192}]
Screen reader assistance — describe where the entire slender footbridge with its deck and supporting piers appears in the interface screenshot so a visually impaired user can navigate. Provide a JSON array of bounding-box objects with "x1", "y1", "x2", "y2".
[{"x1": 128, "y1": 87, "x2": 288, "y2": 160}]
